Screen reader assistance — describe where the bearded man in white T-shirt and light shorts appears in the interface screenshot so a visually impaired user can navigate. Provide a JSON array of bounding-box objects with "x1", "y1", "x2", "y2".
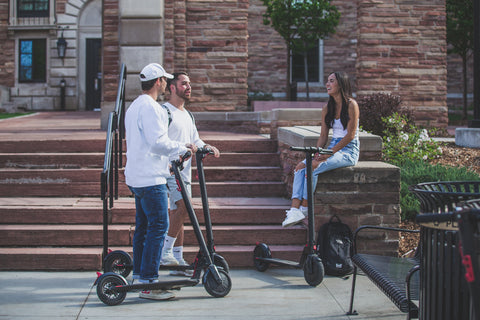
[{"x1": 160, "y1": 72, "x2": 220, "y2": 276}]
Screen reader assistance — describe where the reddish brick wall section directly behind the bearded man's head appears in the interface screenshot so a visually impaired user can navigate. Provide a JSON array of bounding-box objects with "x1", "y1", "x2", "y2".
[{"x1": 165, "y1": 0, "x2": 248, "y2": 111}]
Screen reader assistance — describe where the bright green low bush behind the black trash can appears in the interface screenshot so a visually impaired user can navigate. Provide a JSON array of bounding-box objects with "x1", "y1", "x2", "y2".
[{"x1": 400, "y1": 159, "x2": 480, "y2": 220}]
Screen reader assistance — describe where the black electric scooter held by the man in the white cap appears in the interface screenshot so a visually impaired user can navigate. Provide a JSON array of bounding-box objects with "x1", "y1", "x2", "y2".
[{"x1": 95, "y1": 152, "x2": 232, "y2": 306}]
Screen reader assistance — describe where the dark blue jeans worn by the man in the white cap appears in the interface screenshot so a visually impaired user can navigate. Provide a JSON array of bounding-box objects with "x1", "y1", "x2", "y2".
[{"x1": 129, "y1": 184, "x2": 169, "y2": 280}]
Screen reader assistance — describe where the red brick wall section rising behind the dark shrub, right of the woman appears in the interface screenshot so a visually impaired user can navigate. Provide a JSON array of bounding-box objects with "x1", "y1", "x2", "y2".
[{"x1": 357, "y1": 0, "x2": 448, "y2": 127}]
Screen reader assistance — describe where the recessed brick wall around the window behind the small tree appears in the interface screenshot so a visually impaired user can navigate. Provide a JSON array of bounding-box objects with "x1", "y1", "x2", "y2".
[{"x1": 248, "y1": 0, "x2": 357, "y2": 101}]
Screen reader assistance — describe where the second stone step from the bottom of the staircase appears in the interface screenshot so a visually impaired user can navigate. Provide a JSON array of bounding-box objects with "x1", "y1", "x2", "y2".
[{"x1": 0, "y1": 224, "x2": 306, "y2": 247}]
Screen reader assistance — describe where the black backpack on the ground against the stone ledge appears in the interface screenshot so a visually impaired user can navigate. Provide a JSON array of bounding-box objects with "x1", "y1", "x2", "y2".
[{"x1": 317, "y1": 215, "x2": 353, "y2": 276}]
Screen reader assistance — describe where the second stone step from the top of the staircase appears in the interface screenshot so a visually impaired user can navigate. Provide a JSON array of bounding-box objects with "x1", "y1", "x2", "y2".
[{"x1": 0, "y1": 152, "x2": 279, "y2": 169}]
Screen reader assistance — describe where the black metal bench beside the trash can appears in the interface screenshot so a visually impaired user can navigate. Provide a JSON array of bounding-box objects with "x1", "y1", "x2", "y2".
[{"x1": 347, "y1": 226, "x2": 420, "y2": 319}]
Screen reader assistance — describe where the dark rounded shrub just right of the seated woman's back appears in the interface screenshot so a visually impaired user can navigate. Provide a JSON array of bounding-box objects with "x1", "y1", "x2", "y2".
[{"x1": 357, "y1": 93, "x2": 413, "y2": 136}]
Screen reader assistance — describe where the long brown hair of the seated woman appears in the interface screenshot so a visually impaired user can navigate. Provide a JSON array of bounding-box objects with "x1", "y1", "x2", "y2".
[{"x1": 325, "y1": 72, "x2": 352, "y2": 129}]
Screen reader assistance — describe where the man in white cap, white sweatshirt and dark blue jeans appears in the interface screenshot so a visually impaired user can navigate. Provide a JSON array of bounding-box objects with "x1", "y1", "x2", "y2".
[{"x1": 125, "y1": 63, "x2": 196, "y2": 300}]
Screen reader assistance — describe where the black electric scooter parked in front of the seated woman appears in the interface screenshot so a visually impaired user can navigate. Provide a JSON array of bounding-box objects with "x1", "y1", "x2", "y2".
[{"x1": 253, "y1": 147, "x2": 332, "y2": 287}]
